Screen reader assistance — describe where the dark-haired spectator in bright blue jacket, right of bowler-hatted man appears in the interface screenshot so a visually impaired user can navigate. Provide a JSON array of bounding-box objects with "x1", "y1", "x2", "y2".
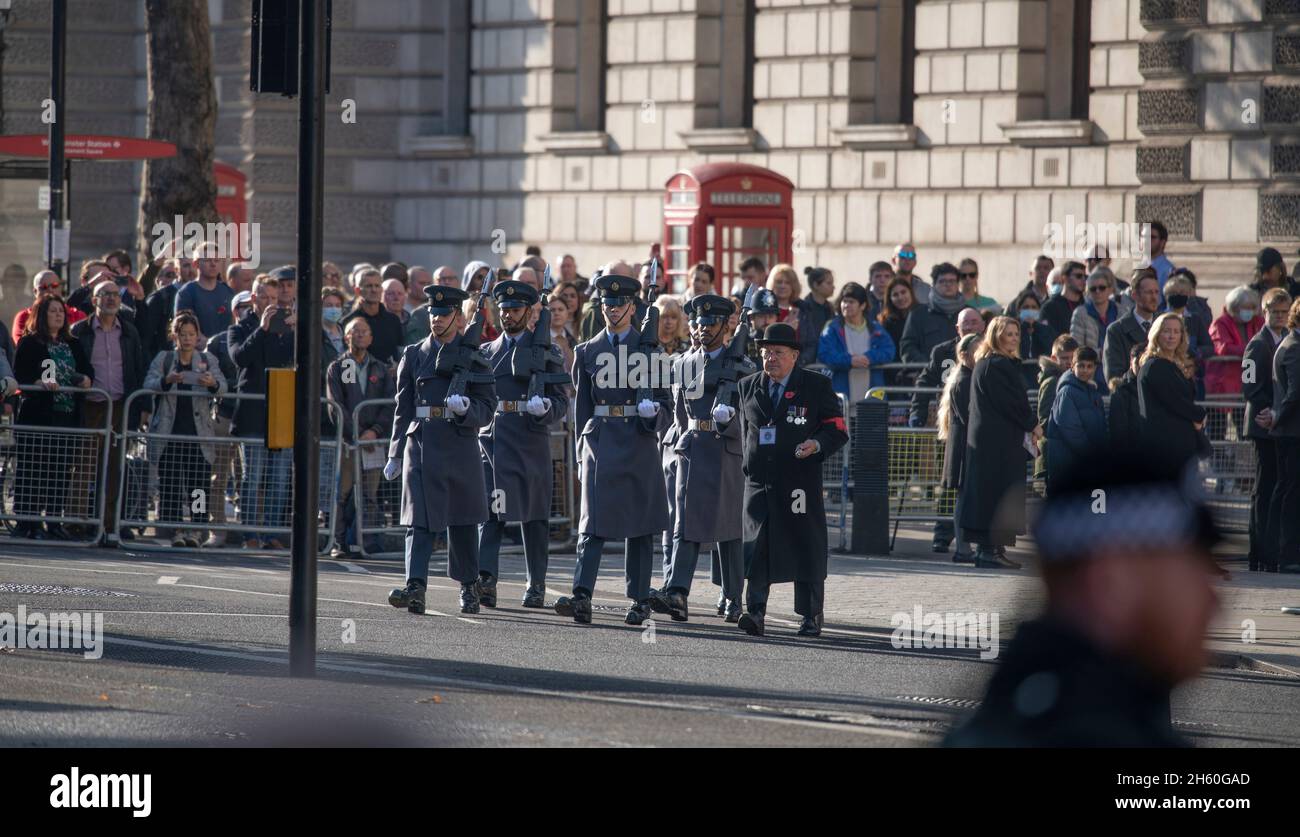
[{"x1": 816, "y1": 282, "x2": 894, "y2": 400}]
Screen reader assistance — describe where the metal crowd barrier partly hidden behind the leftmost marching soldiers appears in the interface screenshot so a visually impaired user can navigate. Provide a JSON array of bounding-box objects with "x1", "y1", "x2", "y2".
[{"x1": 341, "y1": 399, "x2": 577, "y2": 558}]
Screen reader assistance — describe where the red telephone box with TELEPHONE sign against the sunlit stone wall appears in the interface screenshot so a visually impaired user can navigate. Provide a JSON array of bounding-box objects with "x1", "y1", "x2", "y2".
[{"x1": 663, "y1": 162, "x2": 794, "y2": 295}]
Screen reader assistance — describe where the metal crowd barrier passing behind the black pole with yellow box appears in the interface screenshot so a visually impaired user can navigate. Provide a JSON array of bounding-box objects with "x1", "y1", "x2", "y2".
[{"x1": 118, "y1": 390, "x2": 343, "y2": 552}]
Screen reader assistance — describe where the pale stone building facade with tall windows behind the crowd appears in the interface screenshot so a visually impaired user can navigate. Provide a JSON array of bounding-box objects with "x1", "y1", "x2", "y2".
[{"x1": 0, "y1": 0, "x2": 1300, "y2": 317}]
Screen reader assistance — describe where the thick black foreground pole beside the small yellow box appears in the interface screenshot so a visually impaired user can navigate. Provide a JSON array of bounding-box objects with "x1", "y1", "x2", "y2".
[{"x1": 289, "y1": 0, "x2": 325, "y2": 677}]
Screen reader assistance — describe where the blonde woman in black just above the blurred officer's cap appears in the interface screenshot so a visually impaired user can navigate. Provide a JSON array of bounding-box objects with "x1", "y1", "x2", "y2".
[{"x1": 1138, "y1": 313, "x2": 1209, "y2": 463}]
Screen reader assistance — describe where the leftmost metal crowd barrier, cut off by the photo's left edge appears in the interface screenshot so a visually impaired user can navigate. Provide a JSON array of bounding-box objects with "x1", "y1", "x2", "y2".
[{"x1": 0, "y1": 383, "x2": 113, "y2": 545}]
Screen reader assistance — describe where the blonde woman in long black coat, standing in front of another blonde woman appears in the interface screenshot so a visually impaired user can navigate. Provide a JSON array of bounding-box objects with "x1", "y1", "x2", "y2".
[{"x1": 959, "y1": 317, "x2": 1043, "y2": 569}]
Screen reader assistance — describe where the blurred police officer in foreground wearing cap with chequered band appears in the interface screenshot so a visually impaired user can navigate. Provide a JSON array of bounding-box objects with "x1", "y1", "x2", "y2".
[{"x1": 945, "y1": 451, "x2": 1219, "y2": 747}]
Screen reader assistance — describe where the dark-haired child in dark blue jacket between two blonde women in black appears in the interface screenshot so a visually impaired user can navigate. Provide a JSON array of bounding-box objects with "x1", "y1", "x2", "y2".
[{"x1": 1045, "y1": 346, "x2": 1108, "y2": 495}]
